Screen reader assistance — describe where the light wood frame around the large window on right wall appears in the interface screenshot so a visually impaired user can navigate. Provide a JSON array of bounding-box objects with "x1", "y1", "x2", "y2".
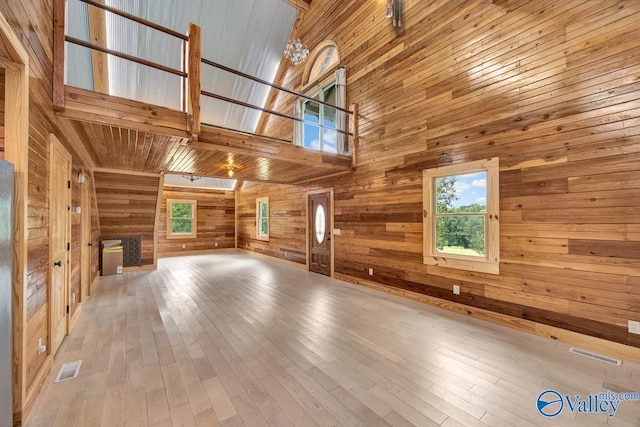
[{"x1": 422, "y1": 157, "x2": 500, "y2": 274}]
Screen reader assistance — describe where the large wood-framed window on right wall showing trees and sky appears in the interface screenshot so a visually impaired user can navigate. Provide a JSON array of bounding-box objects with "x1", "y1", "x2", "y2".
[{"x1": 423, "y1": 158, "x2": 500, "y2": 274}]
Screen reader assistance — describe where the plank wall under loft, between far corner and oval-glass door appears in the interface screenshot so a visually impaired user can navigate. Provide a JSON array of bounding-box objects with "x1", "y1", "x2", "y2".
[{"x1": 237, "y1": 182, "x2": 307, "y2": 264}]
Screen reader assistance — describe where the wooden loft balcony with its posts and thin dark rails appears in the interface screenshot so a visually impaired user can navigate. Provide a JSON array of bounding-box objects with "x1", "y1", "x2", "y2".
[{"x1": 53, "y1": 0, "x2": 357, "y2": 184}]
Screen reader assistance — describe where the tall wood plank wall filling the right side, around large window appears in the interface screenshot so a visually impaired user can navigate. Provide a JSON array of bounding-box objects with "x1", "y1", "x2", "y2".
[{"x1": 254, "y1": 0, "x2": 640, "y2": 346}]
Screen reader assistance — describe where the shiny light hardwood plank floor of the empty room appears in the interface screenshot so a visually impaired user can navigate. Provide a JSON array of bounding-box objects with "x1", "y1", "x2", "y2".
[{"x1": 26, "y1": 253, "x2": 640, "y2": 427}]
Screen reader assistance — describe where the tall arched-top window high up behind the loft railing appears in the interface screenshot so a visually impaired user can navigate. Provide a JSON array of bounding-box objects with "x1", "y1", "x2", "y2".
[{"x1": 294, "y1": 40, "x2": 348, "y2": 154}]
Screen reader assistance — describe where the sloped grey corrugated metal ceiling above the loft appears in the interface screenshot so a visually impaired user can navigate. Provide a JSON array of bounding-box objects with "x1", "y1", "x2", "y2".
[{"x1": 65, "y1": 0, "x2": 296, "y2": 132}]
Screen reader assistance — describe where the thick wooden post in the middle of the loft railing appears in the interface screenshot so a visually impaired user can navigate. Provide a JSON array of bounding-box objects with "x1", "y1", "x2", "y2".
[{"x1": 185, "y1": 23, "x2": 202, "y2": 140}]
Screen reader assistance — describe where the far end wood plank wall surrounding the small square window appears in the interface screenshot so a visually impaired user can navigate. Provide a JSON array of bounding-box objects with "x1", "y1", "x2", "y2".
[{"x1": 157, "y1": 185, "x2": 236, "y2": 257}]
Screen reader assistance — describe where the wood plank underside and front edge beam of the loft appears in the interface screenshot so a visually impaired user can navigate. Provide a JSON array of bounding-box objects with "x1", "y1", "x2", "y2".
[{"x1": 58, "y1": 87, "x2": 351, "y2": 184}]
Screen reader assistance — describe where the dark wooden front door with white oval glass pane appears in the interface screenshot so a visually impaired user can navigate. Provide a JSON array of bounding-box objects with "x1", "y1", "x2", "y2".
[{"x1": 309, "y1": 192, "x2": 331, "y2": 276}]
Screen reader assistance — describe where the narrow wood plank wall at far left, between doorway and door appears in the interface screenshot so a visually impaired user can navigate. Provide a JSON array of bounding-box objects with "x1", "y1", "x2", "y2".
[{"x1": 0, "y1": 0, "x2": 102, "y2": 423}]
